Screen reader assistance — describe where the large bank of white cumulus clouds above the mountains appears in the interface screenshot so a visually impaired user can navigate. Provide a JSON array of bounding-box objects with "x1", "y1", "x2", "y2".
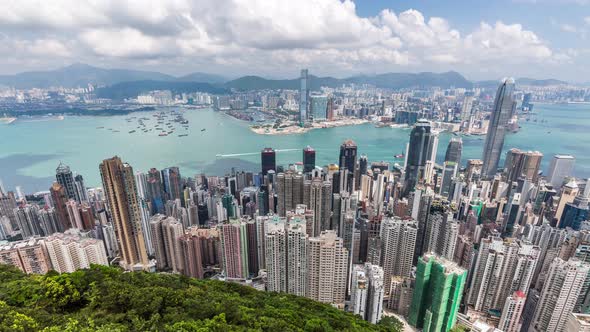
[{"x1": 0, "y1": 0, "x2": 561, "y2": 77}]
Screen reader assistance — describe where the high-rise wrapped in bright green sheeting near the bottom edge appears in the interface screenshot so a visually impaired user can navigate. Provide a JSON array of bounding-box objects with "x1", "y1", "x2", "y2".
[{"x1": 408, "y1": 254, "x2": 467, "y2": 332}]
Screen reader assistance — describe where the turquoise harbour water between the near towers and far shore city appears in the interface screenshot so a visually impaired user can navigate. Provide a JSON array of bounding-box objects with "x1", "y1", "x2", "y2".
[{"x1": 0, "y1": 104, "x2": 590, "y2": 192}]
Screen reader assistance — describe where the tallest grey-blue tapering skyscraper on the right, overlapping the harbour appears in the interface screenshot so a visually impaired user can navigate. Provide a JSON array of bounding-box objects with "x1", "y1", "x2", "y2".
[{"x1": 482, "y1": 78, "x2": 516, "y2": 178}]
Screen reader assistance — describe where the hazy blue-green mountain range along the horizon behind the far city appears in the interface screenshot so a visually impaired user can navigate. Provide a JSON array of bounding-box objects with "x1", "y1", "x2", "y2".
[{"x1": 0, "y1": 64, "x2": 567, "y2": 99}]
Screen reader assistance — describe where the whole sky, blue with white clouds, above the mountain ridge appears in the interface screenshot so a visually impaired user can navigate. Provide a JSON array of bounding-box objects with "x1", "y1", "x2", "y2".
[{"x1": 0, "y1": 0, "x2": 590, "y2": 83}]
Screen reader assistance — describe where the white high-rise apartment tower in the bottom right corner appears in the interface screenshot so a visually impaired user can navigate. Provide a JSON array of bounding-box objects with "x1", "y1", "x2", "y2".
[{"x1": 530, "y1": 258, "x2": 590, "y2": 332}]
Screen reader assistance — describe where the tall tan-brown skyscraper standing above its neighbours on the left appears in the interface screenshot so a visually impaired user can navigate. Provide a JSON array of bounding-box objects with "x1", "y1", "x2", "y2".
[{"x1": 99, "y1": 156, "x2": 152, "y2": 270}]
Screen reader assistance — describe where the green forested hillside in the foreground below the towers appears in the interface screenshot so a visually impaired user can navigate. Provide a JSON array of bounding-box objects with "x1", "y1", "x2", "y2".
[{"x1": 0, "y1": 265, "x2": 399, "y2": 332}]
